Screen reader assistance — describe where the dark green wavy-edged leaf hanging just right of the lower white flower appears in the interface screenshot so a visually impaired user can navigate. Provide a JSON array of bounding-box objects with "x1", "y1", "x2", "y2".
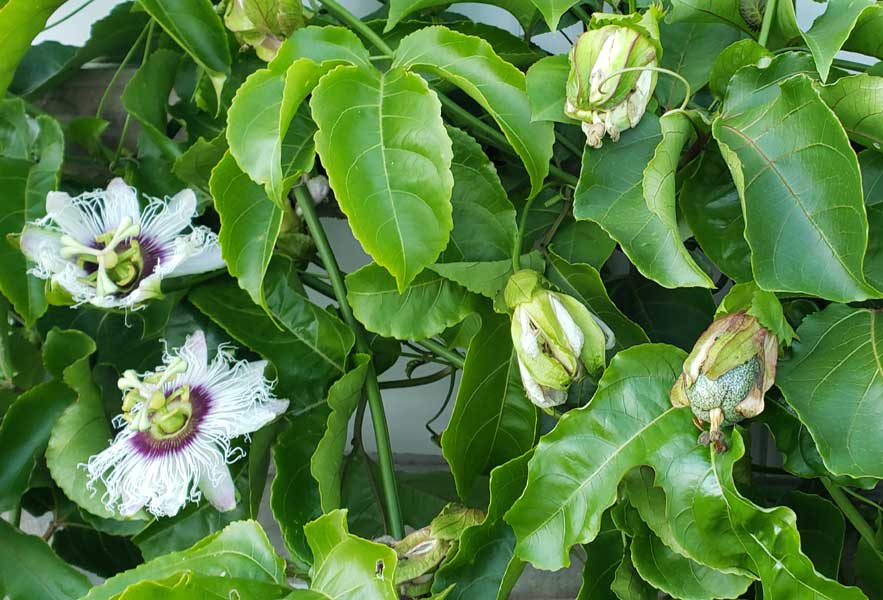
[{"x1": 270, "y1": 402, "x2": 328, "y2": 568}]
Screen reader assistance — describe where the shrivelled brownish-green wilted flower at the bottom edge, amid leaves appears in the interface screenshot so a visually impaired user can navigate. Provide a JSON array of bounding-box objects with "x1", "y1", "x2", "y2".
[{"x1": 386, "y1": 504, "x2": 484, "y2": 598}]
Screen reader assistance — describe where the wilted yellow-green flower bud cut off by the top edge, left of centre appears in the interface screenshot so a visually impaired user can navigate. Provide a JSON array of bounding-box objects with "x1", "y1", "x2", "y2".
[{"x1": 224, "y1": 0, "x2": 303, "y2": 62}]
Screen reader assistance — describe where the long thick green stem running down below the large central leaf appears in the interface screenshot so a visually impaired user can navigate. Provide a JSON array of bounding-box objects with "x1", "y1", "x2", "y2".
[{"x1": 294, "y1": 186, "x2": 405, "y2": 539}]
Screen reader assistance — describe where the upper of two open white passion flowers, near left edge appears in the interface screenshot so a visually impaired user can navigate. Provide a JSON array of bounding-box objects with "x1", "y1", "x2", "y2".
[{"x1": 20, "y1": 178, "x2": 224, "y2": 308}]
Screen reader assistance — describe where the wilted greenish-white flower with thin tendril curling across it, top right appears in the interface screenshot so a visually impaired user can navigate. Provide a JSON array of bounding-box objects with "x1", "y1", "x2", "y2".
[{"x1": 564, "y1": 6, "x2": 662, "y2": 148}]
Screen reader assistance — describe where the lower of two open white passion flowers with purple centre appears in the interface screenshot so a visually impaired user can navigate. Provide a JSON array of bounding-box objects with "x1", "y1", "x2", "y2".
[{"x1": 81, "y1": 331, "x2": 288, "y2": 517}]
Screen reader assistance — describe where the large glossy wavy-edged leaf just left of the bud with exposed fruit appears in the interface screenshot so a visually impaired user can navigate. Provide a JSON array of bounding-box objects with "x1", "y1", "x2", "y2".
[{"x1": 506, "y1": 345, "x2": 695, "y2": 569}]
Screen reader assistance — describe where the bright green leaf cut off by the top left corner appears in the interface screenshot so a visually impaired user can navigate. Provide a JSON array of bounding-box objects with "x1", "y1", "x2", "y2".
[{"x1": 0, "y1": 0, "x2": 64, "y2": 96}]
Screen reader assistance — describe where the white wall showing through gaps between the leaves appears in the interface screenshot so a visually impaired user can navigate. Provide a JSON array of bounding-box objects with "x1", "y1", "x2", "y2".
[{"x1": 36, "y1": 0, "x2": 862, "y2": 455}]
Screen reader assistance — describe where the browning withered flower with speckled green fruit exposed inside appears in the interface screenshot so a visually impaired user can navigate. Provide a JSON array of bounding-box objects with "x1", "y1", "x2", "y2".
[{"x1": 671, "y1": 312, "x2": 778, "y2": 451}]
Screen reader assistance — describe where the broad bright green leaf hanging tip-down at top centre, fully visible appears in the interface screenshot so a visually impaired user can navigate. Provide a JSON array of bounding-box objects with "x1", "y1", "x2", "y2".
[{"x1": 310, "y1": 66, "x2": 453, "y2": 292}]
